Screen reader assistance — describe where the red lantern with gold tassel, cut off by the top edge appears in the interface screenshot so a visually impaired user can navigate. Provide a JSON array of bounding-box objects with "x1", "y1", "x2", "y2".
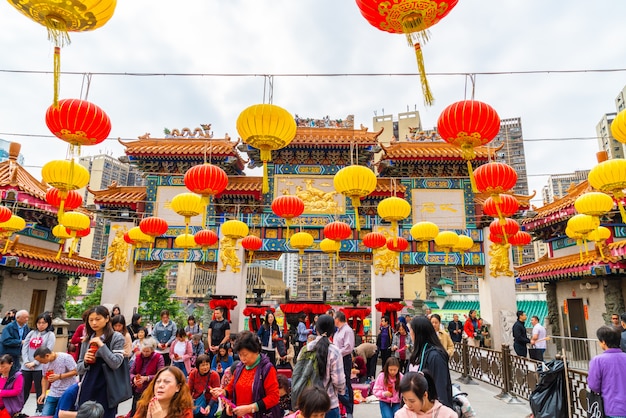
[{"x1": 356, "y1": 0, "x2": 458, "y2": 105}]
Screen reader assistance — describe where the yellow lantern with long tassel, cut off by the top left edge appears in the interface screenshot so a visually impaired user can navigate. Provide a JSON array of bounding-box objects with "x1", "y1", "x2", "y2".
[{"x1": 9, "y1": 0, "x2": 117, "y2": 106}]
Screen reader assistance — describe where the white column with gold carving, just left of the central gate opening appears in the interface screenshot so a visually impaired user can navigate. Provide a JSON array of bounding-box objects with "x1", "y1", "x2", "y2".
[{"x1": 215, "y1": 235, "x2": 248, "y2": 332}]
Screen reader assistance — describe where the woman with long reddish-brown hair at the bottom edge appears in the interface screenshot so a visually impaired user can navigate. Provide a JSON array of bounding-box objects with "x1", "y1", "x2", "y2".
[{"x1": 134, "y1": 366, "x2": 193, "y2": 418}]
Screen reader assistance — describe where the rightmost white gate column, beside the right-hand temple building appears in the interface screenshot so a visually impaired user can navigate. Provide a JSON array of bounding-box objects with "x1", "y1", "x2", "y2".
[{"x1": 478, "y1": 228, "x2": 517, "y2": 347}]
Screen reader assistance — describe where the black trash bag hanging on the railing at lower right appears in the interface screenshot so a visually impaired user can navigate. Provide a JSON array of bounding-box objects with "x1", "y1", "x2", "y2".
[{"x1": 529, "y1": 360, "x2": 568, "y2": 418}]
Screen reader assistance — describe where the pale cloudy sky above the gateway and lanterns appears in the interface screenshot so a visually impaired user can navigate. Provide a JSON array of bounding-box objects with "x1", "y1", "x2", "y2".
[{"x1": 0, "y1": 0, "x2": 626, "y2": 206}]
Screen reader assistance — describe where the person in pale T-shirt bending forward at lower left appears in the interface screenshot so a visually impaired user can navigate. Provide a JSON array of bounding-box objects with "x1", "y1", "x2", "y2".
[{"x1": 34, "y1": 347, "x2": 77, "y2": 416}]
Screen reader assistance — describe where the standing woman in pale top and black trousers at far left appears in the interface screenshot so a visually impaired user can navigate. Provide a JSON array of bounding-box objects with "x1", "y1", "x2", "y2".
[{"x1": 21, "y1": 314, "x2": 54, "y2": 414}]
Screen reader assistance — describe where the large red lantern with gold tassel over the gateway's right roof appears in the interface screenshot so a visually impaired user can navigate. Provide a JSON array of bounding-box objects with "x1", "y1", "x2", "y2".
[{"x1": 437, "y1": 100, "x2": 500, "y2": 192}]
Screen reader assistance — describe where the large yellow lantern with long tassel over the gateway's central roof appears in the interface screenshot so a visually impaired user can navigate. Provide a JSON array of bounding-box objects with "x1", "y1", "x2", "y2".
[{"x1": 237, "y1": 104, "x2": 297, "y2": 193}]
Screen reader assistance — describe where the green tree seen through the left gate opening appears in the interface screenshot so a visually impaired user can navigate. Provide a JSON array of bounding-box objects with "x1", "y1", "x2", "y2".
[{"x1": 139, "y1": 264, "x2": 180, "y2": 323}]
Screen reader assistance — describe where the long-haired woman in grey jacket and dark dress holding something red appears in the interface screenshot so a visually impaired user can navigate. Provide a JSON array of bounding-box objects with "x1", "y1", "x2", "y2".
[{"x1": 76, "y1": 305, "x2": 128, "y2": 418}]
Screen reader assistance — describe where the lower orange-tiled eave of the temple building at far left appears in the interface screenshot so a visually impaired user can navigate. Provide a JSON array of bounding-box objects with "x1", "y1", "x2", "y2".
[{"x1": 2, "y1": 239, "x2": 104, "y2": 276}]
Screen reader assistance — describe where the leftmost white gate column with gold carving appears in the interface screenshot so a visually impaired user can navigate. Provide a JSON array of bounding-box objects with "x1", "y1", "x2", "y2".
[{"x1": 101, "y1": 222, "x2": 141, "y2": 323}]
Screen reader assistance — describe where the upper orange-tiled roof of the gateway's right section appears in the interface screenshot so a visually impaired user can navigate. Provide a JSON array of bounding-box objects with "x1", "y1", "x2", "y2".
[{"x1": 380, "y1": 141, "x2": 504, "y2": 161}]
